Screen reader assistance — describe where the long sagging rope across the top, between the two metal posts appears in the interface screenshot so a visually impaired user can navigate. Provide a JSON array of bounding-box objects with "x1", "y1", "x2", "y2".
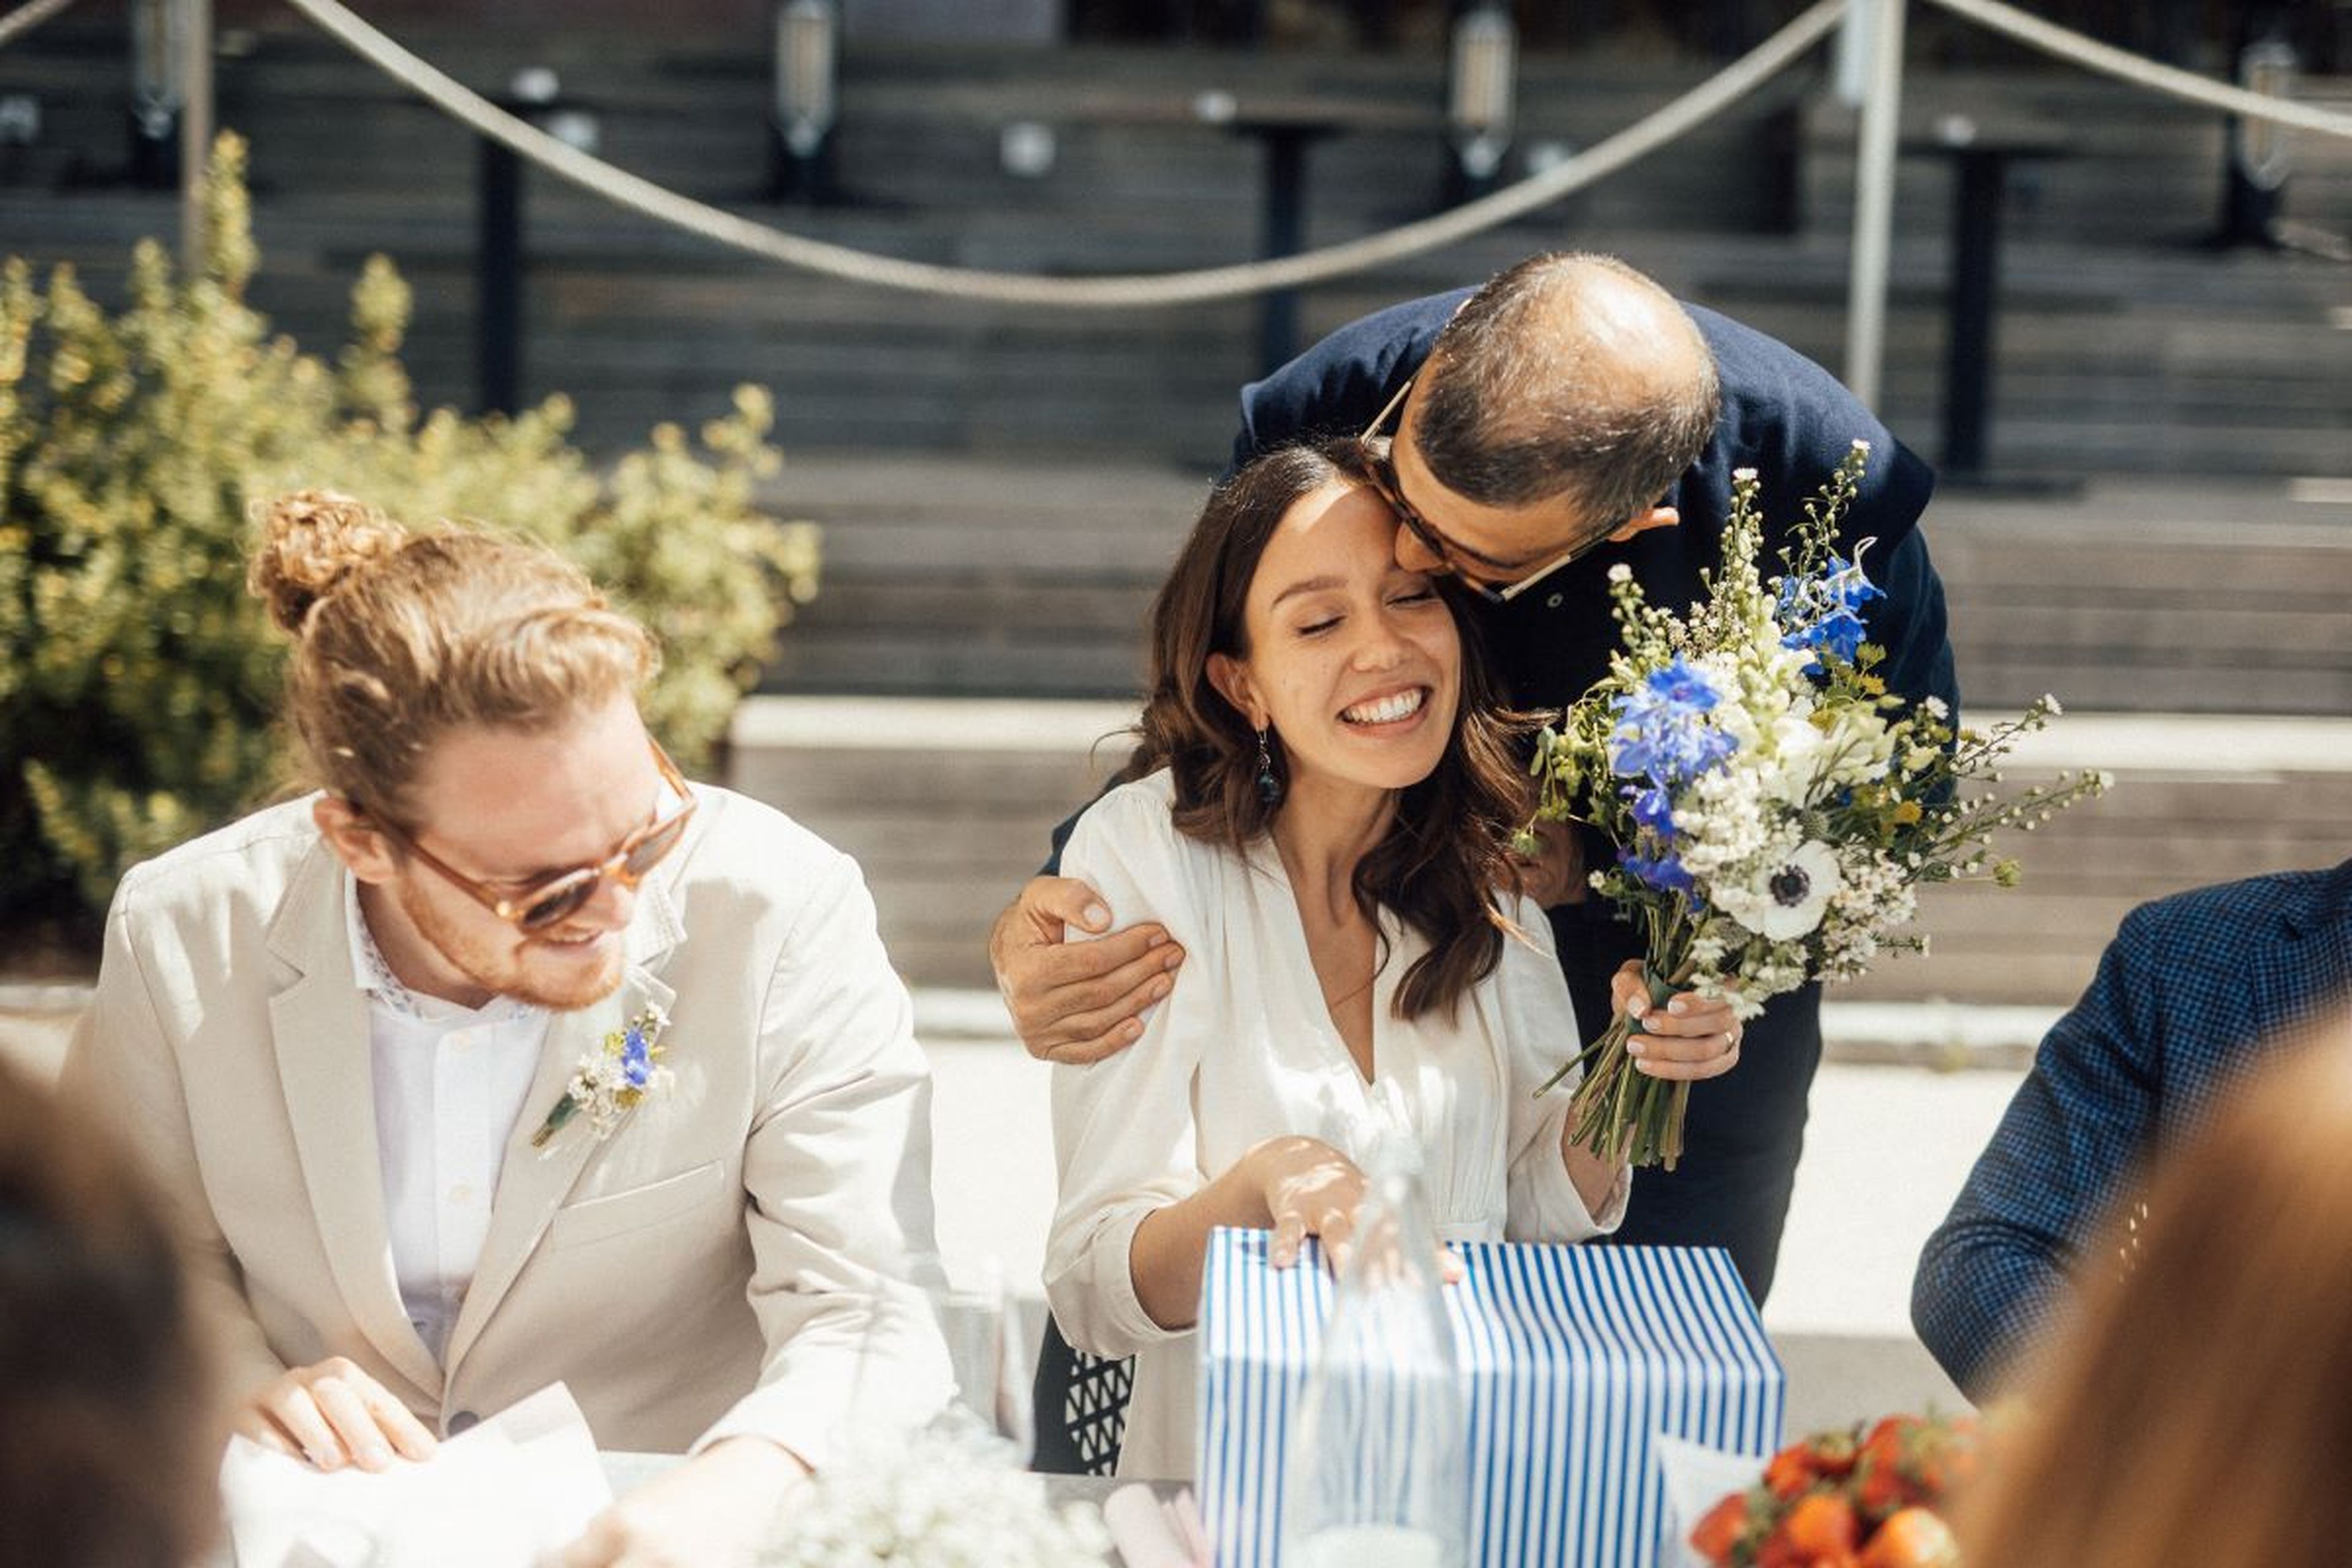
[{"x1": 287, "y1": 0, "x2": 1846, "y2": 308}]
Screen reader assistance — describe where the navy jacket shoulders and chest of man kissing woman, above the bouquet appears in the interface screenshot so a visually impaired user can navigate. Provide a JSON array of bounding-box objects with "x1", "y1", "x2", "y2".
[{"x1": 1232, "y1": 289, "x2": 1959, "y2": 715}]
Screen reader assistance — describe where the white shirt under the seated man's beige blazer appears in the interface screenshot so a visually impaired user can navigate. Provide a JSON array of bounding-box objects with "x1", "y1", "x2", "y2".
[{"x1": 344, "y1": 870, "x2": 548, "y2": 1361}]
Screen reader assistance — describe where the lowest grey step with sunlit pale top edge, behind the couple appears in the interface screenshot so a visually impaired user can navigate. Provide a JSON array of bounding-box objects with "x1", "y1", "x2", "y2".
[{"x1": 729, "y1": 696, "x2": 2352, "y2": 1006}]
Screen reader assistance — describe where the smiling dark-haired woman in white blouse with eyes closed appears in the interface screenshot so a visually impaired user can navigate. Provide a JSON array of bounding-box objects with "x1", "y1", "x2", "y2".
[{"x1": 1047, "y1": 442, "x2": 1675, "y2": 1476}]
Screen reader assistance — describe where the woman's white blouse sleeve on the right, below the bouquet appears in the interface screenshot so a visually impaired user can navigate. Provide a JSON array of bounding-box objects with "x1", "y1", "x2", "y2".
[{"x1": 1493, "y1": 900, "x2": 1632, "y2": 1242}]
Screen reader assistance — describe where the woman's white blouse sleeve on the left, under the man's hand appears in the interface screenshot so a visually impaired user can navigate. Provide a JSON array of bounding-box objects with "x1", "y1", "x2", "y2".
[{"x1": 1044, "y1": 785, "x2": 1216, "y2": 1357}]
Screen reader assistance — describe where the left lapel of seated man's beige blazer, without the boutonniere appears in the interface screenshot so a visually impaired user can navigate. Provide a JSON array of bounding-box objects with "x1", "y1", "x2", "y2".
[{"x1": 268, "y1": 844, "x2": 442, "y2": 1401}]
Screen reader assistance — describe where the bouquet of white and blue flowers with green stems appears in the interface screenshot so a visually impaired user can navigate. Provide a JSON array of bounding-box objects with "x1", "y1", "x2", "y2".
[{"x1": 1521, "y1": 442, "x2": 2108, "y2": 1169}]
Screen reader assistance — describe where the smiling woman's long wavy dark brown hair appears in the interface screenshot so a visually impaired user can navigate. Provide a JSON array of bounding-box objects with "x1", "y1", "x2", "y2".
[{"x1": 1122, "y1": 437, "x2": 1526, "y2": 1018}]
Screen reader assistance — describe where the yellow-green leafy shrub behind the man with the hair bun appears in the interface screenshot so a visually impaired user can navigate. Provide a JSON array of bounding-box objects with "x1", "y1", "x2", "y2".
[{"x1": 0, "y1": 137, "x2": 816, "y2": 919}]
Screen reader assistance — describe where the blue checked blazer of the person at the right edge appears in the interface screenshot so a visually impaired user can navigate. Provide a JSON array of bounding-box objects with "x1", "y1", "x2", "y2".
[{"x1": 1912, "y1": 861, "x2": 2352, "y2": 1399}]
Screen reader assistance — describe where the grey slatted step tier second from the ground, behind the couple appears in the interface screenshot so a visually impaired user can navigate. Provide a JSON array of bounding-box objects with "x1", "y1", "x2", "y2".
[{"x1": 738, "y1": 456, "x2": 2352, "y2": 717}]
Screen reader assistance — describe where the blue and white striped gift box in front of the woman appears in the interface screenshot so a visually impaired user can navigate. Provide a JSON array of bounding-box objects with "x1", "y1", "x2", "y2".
[{"x1": 1199, "y1": 1229, "x2": 1783, "y2": 1568}]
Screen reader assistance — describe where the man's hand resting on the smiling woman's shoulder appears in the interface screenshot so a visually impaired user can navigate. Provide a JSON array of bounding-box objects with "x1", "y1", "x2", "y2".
[{"x1": 988, "y1": 877, "x2": 1183, "y2": 1065}]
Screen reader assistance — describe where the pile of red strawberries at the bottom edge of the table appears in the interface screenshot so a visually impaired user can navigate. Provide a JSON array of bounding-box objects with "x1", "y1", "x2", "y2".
[{"x1": 1686, "y1": 1415, "x2": 1983, "y2": 1568}]
